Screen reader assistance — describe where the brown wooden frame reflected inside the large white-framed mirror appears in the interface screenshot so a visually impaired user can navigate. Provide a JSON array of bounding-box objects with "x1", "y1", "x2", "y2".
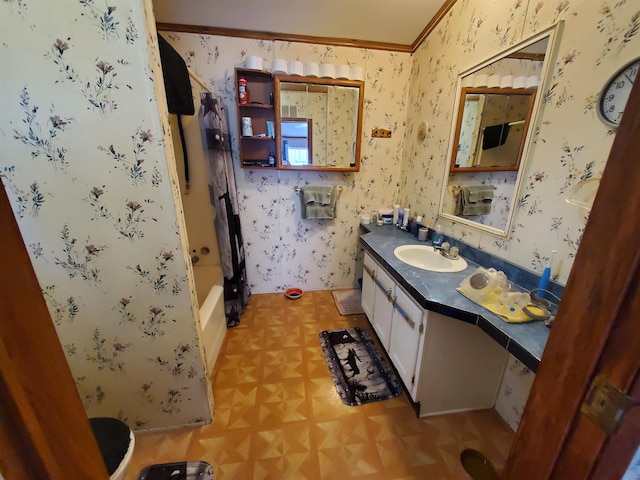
[{"x1": 449, "y1": 87, "x2": 537, "y2": 173}]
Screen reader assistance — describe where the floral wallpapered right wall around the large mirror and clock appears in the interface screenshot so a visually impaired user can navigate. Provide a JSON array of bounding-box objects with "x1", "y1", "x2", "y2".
[{"x1": 399, "y1": 0, "x2": 640, "y2": 284}]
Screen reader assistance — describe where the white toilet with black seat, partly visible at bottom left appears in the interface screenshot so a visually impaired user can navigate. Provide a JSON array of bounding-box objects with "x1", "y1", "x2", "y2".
[{"x1": 89, "y1": 417, "x2": 135, "y2": 480}]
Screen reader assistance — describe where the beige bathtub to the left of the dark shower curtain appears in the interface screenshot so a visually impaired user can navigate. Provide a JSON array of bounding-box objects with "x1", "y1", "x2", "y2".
[{"x1": 193, "y1": 265, "x2": 227, "y2": 374}]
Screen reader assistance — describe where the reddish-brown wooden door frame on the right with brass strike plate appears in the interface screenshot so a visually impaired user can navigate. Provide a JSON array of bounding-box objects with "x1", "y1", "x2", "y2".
[{"x1": 502, "y1": 71, "x2": 640, "y2": 480}]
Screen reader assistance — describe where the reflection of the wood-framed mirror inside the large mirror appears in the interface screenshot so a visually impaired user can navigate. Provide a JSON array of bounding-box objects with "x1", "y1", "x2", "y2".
[{"x1": 451, "y1": 88, "x2": 536, "y2": 171}]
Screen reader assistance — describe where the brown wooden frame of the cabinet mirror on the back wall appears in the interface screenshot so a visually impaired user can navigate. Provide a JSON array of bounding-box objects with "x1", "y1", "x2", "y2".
[{"x1": 273, "y1": 74, "x2": 364, "y2": 172}]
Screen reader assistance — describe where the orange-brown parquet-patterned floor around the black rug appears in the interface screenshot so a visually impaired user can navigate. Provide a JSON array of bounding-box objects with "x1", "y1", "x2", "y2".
[{"x1": 126, "y1": 291, "x2": 513, "y2": 480}]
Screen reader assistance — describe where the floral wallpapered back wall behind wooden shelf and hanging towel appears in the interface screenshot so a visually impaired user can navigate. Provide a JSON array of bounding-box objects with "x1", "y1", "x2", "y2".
[{"x1": 161, "y1": 32, "x2": 411, "y2": 293}]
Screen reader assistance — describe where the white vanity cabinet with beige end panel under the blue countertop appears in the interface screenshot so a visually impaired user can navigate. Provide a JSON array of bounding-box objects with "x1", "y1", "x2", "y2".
[{"x1": 362, "y1": 252, "x2": 509, "y2": 416}]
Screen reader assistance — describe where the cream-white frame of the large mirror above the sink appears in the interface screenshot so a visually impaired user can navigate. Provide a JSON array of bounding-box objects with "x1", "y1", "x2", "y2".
[{"x1": 438, "y1": 21, "x2": 564, "y2": 238}]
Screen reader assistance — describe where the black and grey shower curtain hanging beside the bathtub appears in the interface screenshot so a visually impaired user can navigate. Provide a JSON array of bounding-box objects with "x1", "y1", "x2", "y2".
[{"x1": 198, "y1": 93, "x2": 251, "y2": 327}]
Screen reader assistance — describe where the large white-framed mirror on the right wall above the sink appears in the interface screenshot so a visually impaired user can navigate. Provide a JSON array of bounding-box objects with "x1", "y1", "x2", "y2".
[{"x1": 439, "y1": 23, "x2": 562, "y2": 238}]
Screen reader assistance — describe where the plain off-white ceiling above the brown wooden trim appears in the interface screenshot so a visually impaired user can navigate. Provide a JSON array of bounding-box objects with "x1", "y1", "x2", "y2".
[{"x1": 153, "y1": 0, "x2": 445, "y2": 45}]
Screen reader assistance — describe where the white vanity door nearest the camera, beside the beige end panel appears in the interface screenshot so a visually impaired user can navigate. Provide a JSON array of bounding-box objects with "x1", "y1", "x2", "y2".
[{"x1": 388, "y1": 286, "x2": 424, "y2": 396}]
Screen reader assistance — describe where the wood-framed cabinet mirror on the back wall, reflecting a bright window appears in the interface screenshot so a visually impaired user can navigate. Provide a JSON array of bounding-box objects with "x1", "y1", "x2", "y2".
[{"x1": 274, "y1": 75, "x2": 364, "y2": 172}]
